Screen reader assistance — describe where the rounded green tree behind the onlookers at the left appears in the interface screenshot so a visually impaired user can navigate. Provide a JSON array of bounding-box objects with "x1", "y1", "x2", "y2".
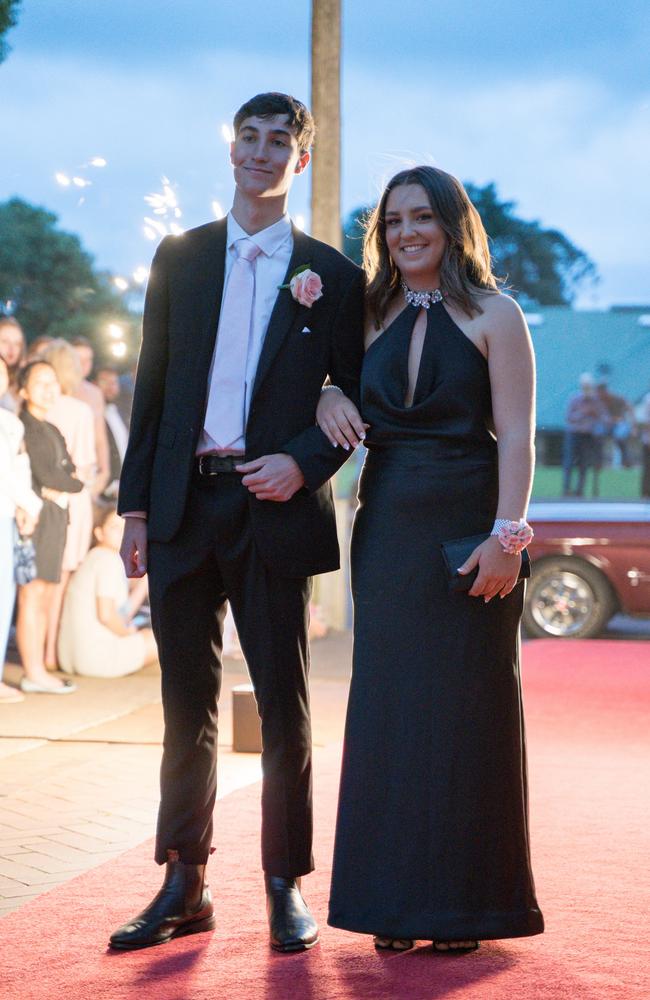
[{"x1": 0, "y1": 198, "x2": 130, "y2": 347}]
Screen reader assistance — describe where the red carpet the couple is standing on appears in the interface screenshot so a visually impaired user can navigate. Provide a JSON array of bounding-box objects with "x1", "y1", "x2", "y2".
[{"x1": 0, "y1": 640, "x2": 650, "y2": 1000}]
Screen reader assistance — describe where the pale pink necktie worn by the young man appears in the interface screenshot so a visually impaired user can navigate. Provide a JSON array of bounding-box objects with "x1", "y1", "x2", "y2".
[{"x1": 204, "y1": 238, "x2": 260, "y2": 449}]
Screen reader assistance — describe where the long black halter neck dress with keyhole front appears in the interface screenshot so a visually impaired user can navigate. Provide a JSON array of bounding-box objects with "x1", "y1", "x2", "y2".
[{"x1": 329, "y1": 302, "x2": 543, "y2": 940}]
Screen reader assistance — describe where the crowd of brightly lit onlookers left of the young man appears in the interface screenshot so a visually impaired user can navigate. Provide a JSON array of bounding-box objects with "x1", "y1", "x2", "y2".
[{"x1": 0, "y1": 316, "x2": 156, "y2": 702}]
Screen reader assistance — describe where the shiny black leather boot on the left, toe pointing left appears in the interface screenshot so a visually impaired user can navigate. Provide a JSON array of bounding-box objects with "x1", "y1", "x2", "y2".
[{"x1": 109, "y1": 851, "x2": 216, "y2": 951}]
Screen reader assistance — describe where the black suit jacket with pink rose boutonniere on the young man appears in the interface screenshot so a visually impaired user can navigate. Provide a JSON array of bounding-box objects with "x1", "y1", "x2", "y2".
[{"x1": 118, "y1": 219, "x2": 363, "y2": 576}]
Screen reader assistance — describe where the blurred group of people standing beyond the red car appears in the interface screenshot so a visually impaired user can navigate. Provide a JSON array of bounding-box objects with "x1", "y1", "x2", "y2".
[{"x1": 562, "y1": 372, "x2": 650, "y2": 498}]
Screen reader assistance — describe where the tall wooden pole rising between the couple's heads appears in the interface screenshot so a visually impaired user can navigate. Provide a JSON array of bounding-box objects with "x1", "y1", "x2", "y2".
[{"x1": 311, "y1": 0, "x2": 342, "y2": 250}]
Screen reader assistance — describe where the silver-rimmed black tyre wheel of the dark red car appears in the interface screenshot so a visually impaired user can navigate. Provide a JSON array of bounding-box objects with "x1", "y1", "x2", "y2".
[{"x1": 522, "y1": 559, "x2": 616, "y2": 639}]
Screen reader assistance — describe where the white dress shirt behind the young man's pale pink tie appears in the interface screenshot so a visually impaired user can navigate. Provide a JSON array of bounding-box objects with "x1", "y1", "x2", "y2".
[{"x1": 196, "y1": 212, "x2": 293, "y2": 455}]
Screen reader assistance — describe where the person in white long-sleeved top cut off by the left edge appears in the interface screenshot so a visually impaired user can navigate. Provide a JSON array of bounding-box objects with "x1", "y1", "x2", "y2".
[{"x1": 0, "y1": 358, "x2": 43, "y2": 704}]
